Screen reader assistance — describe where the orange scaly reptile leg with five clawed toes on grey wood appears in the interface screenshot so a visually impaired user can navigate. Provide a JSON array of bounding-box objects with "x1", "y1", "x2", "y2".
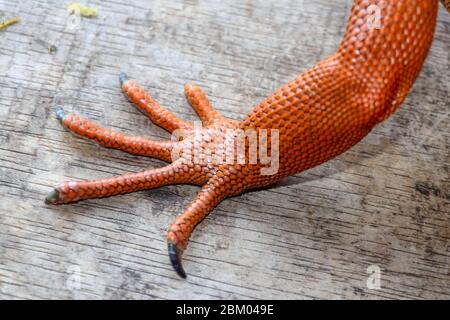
[{"x1": 46, "y1": 0, "x2": 438, "y2": 277}]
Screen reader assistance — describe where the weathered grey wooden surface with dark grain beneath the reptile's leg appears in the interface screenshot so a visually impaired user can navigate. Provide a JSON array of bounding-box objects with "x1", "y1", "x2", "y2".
[{"x1": 0, "y1": 0, "x2": 450, "y2": 299}]
